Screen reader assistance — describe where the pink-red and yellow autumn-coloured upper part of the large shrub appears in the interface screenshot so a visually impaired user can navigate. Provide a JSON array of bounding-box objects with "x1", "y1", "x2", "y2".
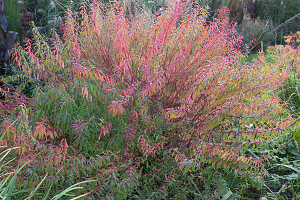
[{"x1": 14, "y1": 1, "x2": 289, "y2": 179}]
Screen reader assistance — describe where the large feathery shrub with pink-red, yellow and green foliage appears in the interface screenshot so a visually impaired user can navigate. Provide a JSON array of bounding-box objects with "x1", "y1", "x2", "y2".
[{"x1": 14, "y1": 1, "x2": 290, "y2": 198}]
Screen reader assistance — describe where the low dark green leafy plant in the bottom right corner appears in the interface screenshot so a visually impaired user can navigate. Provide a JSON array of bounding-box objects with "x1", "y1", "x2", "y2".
[{"x1": 256, "y1": 134, "x2": 300, "y2": 199}]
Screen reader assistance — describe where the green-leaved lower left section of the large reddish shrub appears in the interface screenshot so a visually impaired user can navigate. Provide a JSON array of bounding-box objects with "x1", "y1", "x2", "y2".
[{"x1": 32, "y1": 82, "x2": 127, "y2": 153}]
